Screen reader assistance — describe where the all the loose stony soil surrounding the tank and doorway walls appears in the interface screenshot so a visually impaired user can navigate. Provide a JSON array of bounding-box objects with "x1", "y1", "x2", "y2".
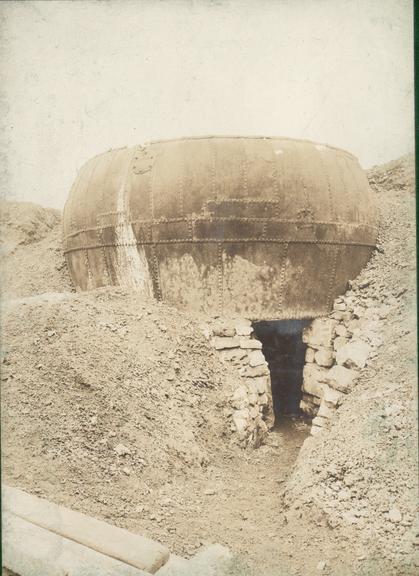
[{"x1": 1, "y1": 157, "x2": 419, "y2": 576}]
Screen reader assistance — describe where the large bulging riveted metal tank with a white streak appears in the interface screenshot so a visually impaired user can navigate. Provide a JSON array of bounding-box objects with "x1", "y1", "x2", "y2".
[{"x1": 64, "y1": 136, "x2": 377, "y2": 320}]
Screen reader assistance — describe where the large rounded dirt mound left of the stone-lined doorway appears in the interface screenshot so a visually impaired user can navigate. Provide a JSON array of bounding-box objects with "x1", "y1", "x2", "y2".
[{"x1": 2, "y1": 289, "x2": 240, "y2": 515}]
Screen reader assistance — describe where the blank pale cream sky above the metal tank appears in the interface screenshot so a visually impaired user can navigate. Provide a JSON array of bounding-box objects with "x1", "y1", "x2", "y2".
[{"x1": 0, "y1": 0, "x2": 414, "y2": 208}]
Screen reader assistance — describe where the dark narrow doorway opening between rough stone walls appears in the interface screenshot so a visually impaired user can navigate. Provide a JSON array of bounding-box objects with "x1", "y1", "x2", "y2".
[{"x1": 253, "y1": 320, "x2": 310, "y2": 424}]
